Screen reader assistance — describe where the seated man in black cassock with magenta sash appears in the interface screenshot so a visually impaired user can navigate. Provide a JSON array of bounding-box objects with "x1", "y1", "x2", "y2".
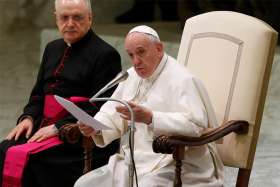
[{"x1": 0, "y1": 0, "x2": 121, "y2": 187}]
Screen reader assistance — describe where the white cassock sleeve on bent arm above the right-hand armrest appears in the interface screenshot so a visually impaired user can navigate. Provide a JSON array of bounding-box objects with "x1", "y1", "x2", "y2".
[{"x1": 153, "y1": 78, "x2": 208, "y2": 137}]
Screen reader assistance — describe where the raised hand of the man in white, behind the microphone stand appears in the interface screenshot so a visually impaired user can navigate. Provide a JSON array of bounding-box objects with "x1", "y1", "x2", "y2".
[{"x1": 116, "y1": 101, "x2": 153, "y2": 124}]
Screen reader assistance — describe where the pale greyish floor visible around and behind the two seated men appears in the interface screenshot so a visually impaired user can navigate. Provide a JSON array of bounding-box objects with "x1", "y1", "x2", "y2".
[{"x1": 0, "y1": 16, "x2": 280, "y2": 187}]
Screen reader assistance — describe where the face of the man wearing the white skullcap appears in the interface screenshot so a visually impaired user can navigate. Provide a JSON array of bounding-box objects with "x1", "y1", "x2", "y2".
[{"x1": 125, "y1": 32, "x2": 163, "y2": 78}]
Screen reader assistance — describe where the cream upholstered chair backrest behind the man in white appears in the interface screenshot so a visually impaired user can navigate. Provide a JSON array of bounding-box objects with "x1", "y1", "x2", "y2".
[{"x1": 177, "y1": 11, "x2": 278, "y2": 169}]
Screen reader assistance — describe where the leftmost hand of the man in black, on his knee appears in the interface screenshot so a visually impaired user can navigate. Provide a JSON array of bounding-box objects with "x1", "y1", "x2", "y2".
[{"x1": 6, "y1": 118, "x2": 33, "y2": 140}]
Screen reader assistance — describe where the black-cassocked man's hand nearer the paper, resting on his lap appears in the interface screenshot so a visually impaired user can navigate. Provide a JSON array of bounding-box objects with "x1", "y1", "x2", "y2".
[{"x1": 27, "y1": 125, "x2": 58, "y2": 143}]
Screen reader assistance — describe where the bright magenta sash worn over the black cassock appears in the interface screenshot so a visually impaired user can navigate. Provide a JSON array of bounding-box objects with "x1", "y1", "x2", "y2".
[{"x1": 2, "y1": 95, "x2": 88, "y2": 187}]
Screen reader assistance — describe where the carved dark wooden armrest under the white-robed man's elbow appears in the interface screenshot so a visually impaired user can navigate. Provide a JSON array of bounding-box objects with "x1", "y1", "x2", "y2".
[{"x1": 153, "y1": 120, "x2": 249, "y2": 154}]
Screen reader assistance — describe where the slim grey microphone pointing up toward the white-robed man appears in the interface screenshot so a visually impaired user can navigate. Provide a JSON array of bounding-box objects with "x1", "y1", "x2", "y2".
[{"x1": 89, "y1": 71, "x2": 128, "y2": 102}]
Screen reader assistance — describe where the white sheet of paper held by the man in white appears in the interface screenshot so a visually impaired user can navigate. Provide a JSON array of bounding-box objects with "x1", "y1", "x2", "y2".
[{"x1": 54, "y1": 95, "x2": 111, "y2": 130}]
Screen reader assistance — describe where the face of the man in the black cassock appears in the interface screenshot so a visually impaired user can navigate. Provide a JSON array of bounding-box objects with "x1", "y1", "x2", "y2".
[{"x1": 55, "y1": 0, "x2": 92, "y2": 44}]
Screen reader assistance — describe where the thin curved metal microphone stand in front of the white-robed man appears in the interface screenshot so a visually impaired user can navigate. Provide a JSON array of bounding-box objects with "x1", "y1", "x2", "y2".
[{"x1": 89, "y1": 97, "x2": 137, "y2": 187}]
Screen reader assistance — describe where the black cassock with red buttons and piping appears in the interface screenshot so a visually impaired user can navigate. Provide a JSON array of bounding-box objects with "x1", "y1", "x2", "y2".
[{"x1": 0, "y1": 30, "x2": 121, "y2": 187}]
